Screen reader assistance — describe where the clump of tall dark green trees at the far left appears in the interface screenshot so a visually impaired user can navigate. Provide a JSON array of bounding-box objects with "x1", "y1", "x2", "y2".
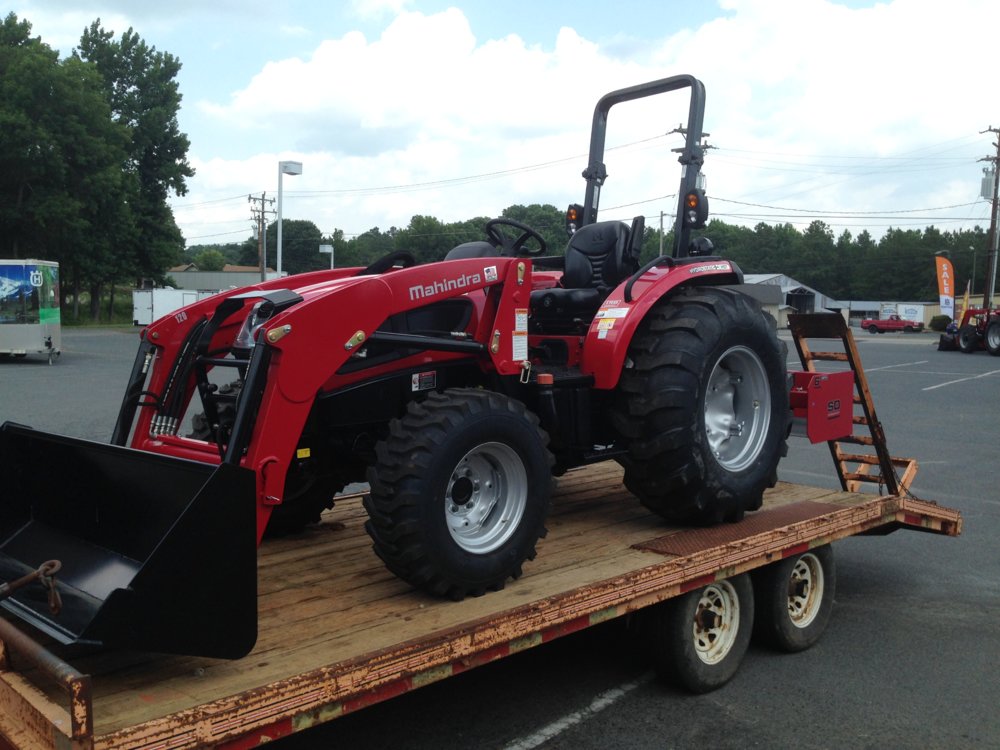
[{"x1": 0, "y1": 13, "x2": 194, "y2": 317}]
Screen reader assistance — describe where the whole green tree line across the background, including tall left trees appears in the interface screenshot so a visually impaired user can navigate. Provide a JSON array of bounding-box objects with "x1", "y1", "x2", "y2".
[{"x1": 0, "y1": 13, "x2": 987, "y2": 319}]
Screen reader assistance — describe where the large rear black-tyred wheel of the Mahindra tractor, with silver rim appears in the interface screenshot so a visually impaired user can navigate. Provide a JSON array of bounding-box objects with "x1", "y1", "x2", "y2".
[{"x1": 611, "y1": 288, "x2": 789, "y2": 523}]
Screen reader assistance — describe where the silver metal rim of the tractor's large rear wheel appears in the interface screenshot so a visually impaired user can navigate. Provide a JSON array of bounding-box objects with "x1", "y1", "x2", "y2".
[{"x1": 705, "y1": 346, "x2": 771, "y2": 471}]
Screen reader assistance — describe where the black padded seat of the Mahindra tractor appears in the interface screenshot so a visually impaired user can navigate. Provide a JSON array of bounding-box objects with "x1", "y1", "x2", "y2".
[{"x1": 531, "y1": 216, "x2": 645, "y2": 334}]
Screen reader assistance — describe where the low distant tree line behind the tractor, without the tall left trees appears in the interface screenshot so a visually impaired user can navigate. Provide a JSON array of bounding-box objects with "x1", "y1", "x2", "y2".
[{"x1": 188, "y1": 204, "x2": 988, "y2": 302}]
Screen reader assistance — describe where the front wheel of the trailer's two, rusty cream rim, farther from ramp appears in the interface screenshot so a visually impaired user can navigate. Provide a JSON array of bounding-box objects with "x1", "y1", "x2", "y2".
[{"x1": 641, "y1": 573, "x2": 754, "y2": 693}]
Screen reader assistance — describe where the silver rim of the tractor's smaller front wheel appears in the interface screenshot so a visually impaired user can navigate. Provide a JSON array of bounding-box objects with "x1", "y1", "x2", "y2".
[{"x1": 445, "y1": 443, "x2": 528, "y2": 555}]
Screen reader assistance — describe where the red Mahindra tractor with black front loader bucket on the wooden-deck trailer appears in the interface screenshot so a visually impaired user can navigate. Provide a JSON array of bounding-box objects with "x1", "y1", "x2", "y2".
[{"x1": 0, "y1": 76, "x2": 789, "y2": 657}]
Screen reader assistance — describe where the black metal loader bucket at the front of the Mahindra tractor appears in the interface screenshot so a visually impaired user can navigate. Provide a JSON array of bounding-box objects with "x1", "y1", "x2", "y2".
[{"x1": 0, "y1": 422, "x2": 257, "y2": 659}]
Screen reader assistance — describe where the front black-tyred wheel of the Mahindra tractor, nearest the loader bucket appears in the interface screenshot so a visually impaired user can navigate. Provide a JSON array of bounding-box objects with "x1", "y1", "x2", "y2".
[{"x1": 365, "y1": 389, "x2": 554, "y2": 600}]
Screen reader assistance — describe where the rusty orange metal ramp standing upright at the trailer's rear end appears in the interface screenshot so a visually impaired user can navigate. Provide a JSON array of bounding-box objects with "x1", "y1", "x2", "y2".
[{"x1": 788, "y1": 313, "x2": 917, "y2": 495}]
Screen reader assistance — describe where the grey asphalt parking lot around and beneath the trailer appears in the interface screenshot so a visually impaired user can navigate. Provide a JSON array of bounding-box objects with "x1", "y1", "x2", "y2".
[{"x1": 0, "y1": 329, "x2": 1000, "y2": 750}]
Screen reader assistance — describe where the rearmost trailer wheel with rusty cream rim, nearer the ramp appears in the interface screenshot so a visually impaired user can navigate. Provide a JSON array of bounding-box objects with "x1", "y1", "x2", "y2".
[{"x1": 752, "y1": 544, "x2": 837, "y2": 652}]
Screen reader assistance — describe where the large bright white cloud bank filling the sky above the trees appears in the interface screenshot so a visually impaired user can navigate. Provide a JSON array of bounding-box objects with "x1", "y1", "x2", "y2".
[{"x1": 166, "y1": 0, "x2": 1000, "y2": 247}]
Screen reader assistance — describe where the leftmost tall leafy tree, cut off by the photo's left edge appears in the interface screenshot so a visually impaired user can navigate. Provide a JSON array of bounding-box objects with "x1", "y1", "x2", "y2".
[{"x1": 0, "y1": 14, "x2": 133, "y2": 315}]
